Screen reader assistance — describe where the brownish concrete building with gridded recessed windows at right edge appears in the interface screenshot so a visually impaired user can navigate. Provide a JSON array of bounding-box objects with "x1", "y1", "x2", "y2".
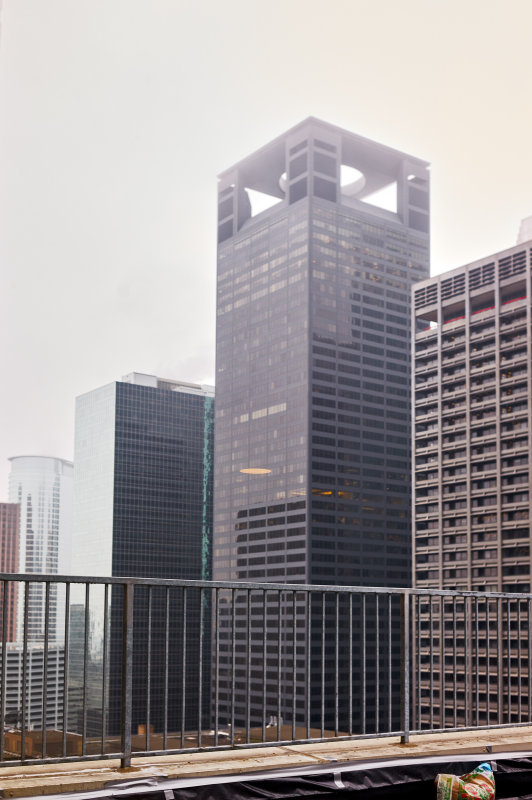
[{"x1": 413, "y1": 236, "x2": 532, "y2": 725}]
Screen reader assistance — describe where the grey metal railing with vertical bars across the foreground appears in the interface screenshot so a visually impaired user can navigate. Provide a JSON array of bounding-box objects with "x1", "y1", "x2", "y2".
[{"x1": 0, "y1": 574, "x2": 532, "y2": 766}]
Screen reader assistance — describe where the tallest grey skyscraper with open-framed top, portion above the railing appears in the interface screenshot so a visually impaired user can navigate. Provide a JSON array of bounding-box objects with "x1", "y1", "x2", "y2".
[{"x1": 213, "y1": 118, "x2": 429, "y2": 732}]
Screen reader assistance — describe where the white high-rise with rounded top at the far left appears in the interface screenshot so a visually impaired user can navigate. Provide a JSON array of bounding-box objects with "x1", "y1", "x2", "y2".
[{"x1": 9, "y1": 456, "x2": 73, "y2": 643}]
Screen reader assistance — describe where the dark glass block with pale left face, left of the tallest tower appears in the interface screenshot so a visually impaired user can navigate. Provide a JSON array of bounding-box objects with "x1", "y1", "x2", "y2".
[{"x1": 73, "y1": 373, "x2": 214, "y2": 730}]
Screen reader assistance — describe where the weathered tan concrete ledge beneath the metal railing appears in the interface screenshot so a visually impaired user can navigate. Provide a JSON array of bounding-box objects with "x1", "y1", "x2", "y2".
[{"x1": 0, "y1": 726, "x2": 532, "y2": 797}]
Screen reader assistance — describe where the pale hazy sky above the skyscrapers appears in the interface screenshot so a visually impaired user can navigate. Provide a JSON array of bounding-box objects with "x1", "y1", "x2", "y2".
[{"x1": 0, "y1": 0, "x2": 532, "y2": 500}]
